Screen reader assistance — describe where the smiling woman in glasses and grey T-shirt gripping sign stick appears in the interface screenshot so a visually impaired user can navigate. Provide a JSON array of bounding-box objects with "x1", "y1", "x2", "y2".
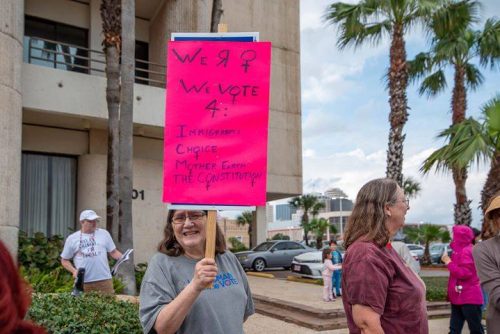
[{"x1": 139, "y1": 210, "x2": 254, "y2": 333}]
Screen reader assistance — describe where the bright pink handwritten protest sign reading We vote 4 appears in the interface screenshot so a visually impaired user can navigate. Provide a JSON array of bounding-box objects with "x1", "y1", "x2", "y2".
[{"x1": 163, "y1": 41, "x2": 271, "y2": 205}]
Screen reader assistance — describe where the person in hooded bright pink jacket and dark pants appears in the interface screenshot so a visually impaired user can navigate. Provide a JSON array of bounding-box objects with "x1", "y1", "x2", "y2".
[{"x1": 441, "y1": 225, "x2": 484, "y2": 334}]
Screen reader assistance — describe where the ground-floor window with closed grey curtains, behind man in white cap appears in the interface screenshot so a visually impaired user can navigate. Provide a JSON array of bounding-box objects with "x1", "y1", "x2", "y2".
[{"x1": 20, "y1": 153, "x2": 77, "y2": 236}]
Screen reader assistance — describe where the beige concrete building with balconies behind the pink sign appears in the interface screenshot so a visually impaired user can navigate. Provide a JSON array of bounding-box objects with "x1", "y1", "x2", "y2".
[{"x1": 0, "y1": 0, "x2": 302, "y2": 262}]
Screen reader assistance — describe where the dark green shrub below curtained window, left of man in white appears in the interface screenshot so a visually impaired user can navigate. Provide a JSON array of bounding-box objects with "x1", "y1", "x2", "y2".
[{"x1": 18, "y1": 231, "x2": 64, "y2": 273}]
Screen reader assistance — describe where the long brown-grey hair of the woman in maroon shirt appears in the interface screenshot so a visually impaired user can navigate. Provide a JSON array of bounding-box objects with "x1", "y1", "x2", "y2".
[{"x1": 344, "y1": 178, "x2": 398, "y2": 249}]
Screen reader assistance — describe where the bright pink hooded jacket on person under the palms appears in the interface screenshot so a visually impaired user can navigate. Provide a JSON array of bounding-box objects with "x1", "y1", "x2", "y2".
[{"x1": 448, "y1": 225, "x2": 483, "y2": 305}]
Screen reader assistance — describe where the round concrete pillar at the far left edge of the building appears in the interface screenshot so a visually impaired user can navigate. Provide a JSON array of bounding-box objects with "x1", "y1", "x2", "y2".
[{"x1": 0, "y1": 0, "x2": 24, "y2": 256}]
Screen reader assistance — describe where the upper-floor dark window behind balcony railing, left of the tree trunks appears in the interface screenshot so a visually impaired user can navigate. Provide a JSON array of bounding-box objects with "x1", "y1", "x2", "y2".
[{"x1": 23, "y1": 16, "x2": 89, "y2": 73}]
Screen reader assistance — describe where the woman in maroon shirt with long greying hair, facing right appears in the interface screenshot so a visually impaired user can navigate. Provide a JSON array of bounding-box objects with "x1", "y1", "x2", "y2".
[{"x1": 342, "y1": 179, "x2": 429, "y2": 334}]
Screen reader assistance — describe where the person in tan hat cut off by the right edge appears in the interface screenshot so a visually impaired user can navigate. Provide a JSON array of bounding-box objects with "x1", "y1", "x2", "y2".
[{"x1": 473, "y1": 194, "x2": 500, "y2": 334}]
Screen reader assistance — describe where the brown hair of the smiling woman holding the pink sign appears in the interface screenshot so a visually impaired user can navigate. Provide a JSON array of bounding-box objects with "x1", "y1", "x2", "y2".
[{"x1": 158, "y1": 210, "x2": 226, "y2": 256}]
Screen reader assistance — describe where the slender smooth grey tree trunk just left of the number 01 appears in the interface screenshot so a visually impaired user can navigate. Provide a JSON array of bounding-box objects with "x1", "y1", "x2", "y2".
[{"x1": 118, "y1": 0, "x2": 136, "y2": 295}]
